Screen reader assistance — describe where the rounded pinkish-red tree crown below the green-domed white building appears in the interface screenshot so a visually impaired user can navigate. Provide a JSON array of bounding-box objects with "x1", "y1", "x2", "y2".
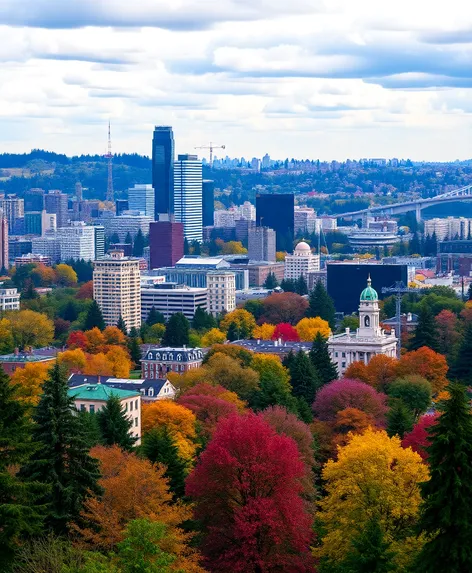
[{"x1": 313, "y1": 378, "x2": 387, "y2": 426}]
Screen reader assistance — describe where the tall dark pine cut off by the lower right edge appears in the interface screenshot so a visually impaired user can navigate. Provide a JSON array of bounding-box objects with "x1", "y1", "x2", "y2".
[{"x1": 415, "y1": 384, "x2": 472, "y2": 573}]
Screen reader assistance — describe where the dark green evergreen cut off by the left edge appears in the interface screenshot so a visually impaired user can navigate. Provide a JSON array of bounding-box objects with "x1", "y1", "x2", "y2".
[{"x1": 0, "y1": 367, "x2": 44, "y2": 571}]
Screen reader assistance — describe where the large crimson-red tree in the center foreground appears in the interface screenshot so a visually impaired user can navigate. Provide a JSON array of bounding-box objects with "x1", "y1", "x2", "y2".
[{"x1": 186, "y1": 413, "x2": 314, "y2": 573}]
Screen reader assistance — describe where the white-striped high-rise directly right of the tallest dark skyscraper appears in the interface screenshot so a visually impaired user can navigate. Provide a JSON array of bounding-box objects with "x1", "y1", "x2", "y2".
[{"x1": 174, "y1": 155, "x2": 203, "y2": 242}]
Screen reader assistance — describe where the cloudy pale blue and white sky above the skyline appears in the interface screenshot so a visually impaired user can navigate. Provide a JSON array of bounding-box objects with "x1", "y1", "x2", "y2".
[{"x1": 0, "y1": 0, "x2": 472, "y2": 161}]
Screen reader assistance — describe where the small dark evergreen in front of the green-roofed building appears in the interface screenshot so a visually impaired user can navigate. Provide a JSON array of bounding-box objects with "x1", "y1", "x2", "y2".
[{"x1": 97, "y1": 394, "x2": 137, "y2": 450}]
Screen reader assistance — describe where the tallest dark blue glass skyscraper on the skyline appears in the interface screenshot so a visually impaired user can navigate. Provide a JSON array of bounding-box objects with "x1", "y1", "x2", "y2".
[{"x1": 152, "y1": 126, "x2": 174, "y2": 221}]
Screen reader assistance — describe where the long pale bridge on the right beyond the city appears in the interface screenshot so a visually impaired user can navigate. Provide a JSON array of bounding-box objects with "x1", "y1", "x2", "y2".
[{"x1": 337, "y1": 185, "x2": 472, "y2": 221}]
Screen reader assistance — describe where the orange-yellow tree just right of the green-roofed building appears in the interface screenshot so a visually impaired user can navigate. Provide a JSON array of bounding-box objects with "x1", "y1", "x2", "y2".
[{"x1": 142, "y1": 400, "x2": 196, "y2": 461}]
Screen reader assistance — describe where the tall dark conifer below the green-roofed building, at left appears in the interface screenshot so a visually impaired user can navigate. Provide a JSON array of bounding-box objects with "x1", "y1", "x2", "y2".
[{"x1": 20, "y1": 363, "x2": 101, "y2": 534}]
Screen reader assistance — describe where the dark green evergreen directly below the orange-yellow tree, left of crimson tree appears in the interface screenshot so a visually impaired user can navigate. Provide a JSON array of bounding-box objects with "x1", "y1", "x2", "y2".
[{"x1": 141, "y1": 427, "x2": 187, "y2": 499}]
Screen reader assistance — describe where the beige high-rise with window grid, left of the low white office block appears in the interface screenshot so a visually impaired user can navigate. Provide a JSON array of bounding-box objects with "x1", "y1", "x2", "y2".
[{"x1": 93, "y1": 251, "x2": 141, "y2": 331}]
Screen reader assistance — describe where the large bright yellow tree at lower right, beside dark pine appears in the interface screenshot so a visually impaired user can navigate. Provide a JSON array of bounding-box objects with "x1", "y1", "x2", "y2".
[{"x1": 315, "y1": 428, "x2": 429, "y2": 572}]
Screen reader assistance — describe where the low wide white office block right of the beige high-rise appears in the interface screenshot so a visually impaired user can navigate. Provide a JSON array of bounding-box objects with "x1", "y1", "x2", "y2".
[{"x1": 141, "y1": 283, "x2": 208, "y2": 322}]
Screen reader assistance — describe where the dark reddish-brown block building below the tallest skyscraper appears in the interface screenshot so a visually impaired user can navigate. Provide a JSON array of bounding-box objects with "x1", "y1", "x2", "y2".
[{"x1": 149, "y1": 221, "x2": 184, "y2": 269}]
